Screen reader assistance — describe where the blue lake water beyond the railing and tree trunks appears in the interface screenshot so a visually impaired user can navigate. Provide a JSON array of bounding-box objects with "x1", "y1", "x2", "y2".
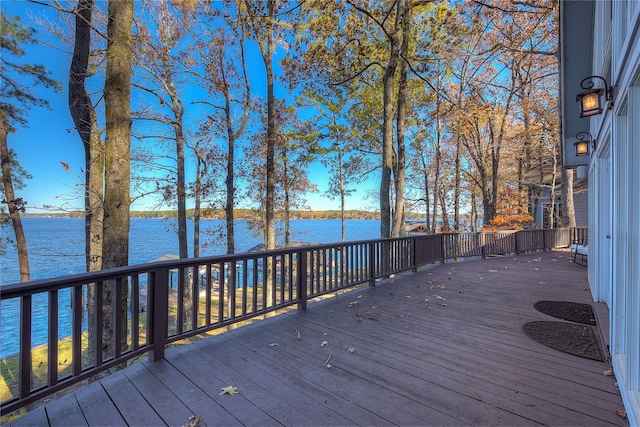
[{"x1": 0, "y1": 218, "x2": 380, "y2": 358}]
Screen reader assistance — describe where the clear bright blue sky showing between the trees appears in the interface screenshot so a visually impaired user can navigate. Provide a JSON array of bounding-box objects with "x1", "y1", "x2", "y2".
[{"x1": 2, "y1": 0, "x2": 378, "y2": 213}]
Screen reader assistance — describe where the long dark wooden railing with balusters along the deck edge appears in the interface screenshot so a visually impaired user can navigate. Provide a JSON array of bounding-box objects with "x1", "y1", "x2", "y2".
[{"x1": 0, "y1": 228, "x2": 574, "y2": 415}]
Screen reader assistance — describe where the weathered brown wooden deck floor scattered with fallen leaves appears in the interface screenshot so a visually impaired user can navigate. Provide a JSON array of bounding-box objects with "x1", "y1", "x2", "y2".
[{"x1": 13, "y1": 251, "x2": 625, "y2": 426}]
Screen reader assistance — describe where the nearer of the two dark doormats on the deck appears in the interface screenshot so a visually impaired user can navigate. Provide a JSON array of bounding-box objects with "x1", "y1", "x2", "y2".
[{"x1": 522, "y1": 321, "x2": 604, "y2": 362}]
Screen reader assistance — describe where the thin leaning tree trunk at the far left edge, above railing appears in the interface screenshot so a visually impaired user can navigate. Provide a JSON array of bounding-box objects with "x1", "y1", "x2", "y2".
[{"x1": 0, "y1": 120, "x2": 31, "y2": 282}]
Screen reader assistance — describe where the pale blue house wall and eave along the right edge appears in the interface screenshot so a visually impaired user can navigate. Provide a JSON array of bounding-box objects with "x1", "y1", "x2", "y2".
[{"x1": 560, "y1": 0, "x2": 640, "y2": 426}]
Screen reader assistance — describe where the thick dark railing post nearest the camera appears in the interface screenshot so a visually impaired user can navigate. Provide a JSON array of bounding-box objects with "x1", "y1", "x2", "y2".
[{"x1": 147, "y1": 268, "x2": 169, "y2": 362}]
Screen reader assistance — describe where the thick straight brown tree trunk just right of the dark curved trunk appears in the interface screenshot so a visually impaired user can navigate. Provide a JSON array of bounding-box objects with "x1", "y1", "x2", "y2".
[{"x1": 102, "y1": 0, "x2": 133, "y2": 357}]
